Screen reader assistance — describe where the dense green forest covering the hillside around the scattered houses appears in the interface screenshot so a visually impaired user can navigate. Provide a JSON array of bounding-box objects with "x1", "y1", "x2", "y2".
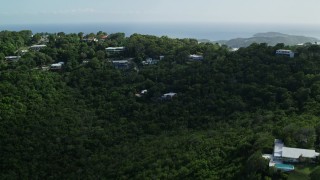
[{"x1": 0, "y1": 31, "x2": 320, "y2": 179}]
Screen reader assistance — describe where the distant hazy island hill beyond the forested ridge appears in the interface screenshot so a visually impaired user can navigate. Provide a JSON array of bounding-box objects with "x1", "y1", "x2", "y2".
[{"x1": 199, "y1": 32, "x2": 319, "y2": 48}]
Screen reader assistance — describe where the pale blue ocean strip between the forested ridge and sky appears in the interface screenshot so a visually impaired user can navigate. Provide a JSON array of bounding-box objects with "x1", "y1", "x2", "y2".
[{"x1": 0, "y1": 23, "x2": 320, "y2": 41}]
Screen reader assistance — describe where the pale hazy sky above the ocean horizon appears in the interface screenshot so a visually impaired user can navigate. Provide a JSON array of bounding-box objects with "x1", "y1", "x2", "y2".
[{"x1": 0, "y1": 0, "x2": 320, "y2": 26}]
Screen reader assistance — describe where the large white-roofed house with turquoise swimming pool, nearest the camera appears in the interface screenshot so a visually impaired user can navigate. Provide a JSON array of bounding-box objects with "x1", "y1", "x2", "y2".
[{"x1": 262, "y1": 139, "x2": 320, "y2": 171}]
